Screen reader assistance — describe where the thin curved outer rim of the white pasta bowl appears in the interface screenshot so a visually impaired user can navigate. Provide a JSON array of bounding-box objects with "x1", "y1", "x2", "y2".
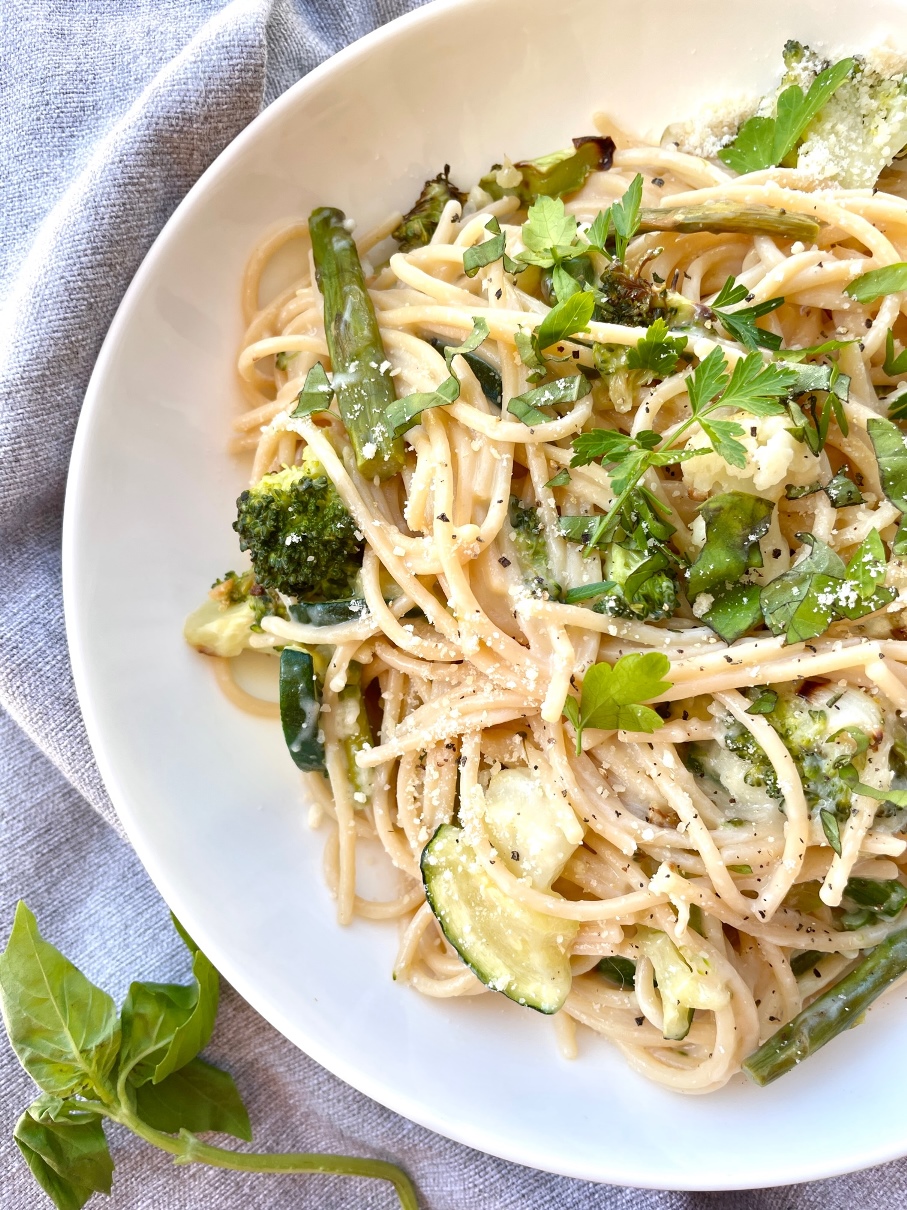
[{"x1": 62, "y1": 0, "x2": 907, "y2": 1191}]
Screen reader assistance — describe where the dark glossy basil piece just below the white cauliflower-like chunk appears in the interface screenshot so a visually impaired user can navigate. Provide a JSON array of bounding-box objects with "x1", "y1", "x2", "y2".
[{"x1": 688, "y1": 491, "x2": 774, "y2": 600}]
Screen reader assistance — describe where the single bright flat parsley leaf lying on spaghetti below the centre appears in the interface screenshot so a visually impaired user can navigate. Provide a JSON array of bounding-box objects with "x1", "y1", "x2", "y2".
[{"x1": 564, "y1": 651, "x2": 671, "y2": 754}]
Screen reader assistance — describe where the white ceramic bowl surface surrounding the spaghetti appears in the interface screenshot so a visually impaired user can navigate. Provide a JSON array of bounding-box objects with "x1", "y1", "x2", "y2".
[{"x1": 64, "y1": 0, "x2": 907, "y2": 1189}]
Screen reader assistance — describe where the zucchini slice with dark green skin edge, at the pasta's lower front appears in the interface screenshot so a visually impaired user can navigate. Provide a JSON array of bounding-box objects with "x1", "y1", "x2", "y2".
[{"x1": 422, "y1": 824, "x2": 579, "y2": 1013}]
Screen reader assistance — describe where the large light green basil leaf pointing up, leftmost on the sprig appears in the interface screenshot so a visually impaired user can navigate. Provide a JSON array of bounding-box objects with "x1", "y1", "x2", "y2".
[{"x1": 0, "y1": 900, "x2": 120, "y2": 1096}]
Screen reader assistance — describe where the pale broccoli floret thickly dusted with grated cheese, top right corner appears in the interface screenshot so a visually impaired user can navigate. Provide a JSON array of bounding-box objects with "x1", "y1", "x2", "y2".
[{"x1": 797, "y1": 55, "x2": 907, "y2": 189}]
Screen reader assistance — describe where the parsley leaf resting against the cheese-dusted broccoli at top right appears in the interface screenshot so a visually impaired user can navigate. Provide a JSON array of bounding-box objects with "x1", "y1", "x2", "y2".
[{"x1": 718, "y1": 59, "x2": 855, "y2": 173}]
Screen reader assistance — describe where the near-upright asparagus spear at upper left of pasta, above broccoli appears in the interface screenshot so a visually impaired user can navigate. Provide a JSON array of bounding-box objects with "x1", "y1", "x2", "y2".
[{"x1": 308, "y1": 206, "x2": 403, "y2": 479}]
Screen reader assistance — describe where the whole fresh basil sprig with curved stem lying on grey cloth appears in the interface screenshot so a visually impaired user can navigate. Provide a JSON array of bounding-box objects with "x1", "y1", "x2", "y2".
[{"x1": 0, "y1": 903, "x2": 417, "y2": 1210}]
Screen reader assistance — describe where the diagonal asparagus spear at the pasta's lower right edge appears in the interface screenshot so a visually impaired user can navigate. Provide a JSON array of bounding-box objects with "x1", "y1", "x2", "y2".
[{"x1": 744, "y1": 928, "x2": 907, "y2": 1085}]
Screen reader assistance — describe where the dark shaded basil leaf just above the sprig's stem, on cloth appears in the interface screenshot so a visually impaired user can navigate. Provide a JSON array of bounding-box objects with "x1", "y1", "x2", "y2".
[{"x1": 135, "y1": 1059, "x2": 252, "y2": 1142}]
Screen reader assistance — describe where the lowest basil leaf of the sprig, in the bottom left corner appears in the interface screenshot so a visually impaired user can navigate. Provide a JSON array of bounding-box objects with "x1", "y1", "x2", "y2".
[{"x1": 13, "y1": 1112, "x2": 114, "y2": 1210}]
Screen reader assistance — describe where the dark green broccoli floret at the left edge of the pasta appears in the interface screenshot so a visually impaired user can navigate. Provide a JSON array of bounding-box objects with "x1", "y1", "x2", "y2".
[{"x1": 233, "y1": 457, "x2": 363, "y2": 600}]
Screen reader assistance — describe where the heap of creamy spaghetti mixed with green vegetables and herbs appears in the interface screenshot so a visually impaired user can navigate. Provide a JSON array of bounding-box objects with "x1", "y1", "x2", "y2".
[{"x1": 187, "y1": 48, "x2": 907, "y2": 1093}]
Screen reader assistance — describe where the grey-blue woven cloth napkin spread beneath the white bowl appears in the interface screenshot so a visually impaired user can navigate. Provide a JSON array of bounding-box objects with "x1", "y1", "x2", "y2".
[{"x1": 0, "y1": 0, "x2": 907, "y2": 1210}]
